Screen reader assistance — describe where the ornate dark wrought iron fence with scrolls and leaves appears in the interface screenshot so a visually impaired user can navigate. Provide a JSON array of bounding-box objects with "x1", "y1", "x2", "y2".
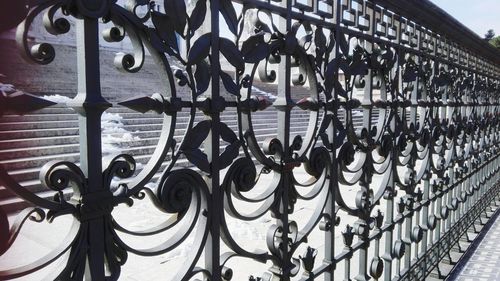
[{"x1": 0, "y1": 0, "x2": 500, "y2": 280}]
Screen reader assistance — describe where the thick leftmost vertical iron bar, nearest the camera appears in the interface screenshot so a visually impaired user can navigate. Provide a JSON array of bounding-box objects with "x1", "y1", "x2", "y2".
[{"x1": 71, "y1": 18, "x2": 111, "y2": 280}]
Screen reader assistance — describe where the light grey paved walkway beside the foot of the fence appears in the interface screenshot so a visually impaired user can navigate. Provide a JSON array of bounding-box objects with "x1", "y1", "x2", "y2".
[{"x1": 451, "y1": 213, "x2": 500, "y2": 281}]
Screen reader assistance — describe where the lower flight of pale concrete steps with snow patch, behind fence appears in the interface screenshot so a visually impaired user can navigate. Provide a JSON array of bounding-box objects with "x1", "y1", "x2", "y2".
[{"x1": 0, "y1": 101, "x2": 372, "y2": 212}]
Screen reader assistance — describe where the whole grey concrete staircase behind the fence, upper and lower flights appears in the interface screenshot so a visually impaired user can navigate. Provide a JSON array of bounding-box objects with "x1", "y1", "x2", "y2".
[{"x1": 0, "y1": 40, "x2": 382, "y2": 213}]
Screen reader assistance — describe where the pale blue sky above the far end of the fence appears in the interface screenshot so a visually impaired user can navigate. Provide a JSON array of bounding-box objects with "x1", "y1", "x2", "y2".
[{"x1": 431, "y1": 0, "x2": 500, "y2": 37}]
